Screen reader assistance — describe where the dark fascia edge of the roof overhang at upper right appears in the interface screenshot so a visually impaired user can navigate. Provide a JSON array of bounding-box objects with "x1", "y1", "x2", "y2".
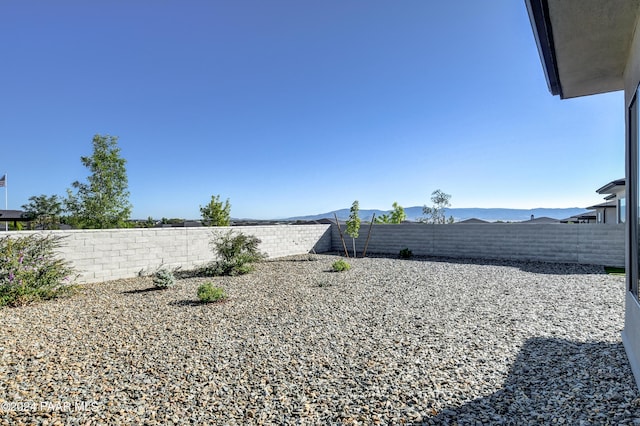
[{"x1": 525, "y1": 0, "x2": 564, "y2": 99}]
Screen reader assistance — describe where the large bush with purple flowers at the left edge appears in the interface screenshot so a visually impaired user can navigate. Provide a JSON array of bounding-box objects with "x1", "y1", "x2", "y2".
[{"x1": 0, "y1": 234, "x2": 77, "y2": 306}]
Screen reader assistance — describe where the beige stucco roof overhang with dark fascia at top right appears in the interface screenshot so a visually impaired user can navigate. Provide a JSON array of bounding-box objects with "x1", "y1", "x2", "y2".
[{"x1": 525, "y1": 0, "x2": 640, "y2": 99}]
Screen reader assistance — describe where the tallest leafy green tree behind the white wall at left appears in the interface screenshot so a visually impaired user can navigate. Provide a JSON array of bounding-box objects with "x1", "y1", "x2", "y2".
[{"x1": 65, "y1": 135, "x2": 131, "y2": 229}]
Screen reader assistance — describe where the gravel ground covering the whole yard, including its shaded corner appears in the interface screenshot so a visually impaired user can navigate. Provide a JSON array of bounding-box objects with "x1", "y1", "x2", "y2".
[{"x1": 0, "y1": 255, "x2": 640, "y2": 425}]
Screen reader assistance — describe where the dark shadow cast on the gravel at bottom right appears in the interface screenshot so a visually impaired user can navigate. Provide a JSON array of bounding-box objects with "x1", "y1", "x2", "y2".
[{"x1": 423, "y1": 338, "x2": 640, "y2": 425}]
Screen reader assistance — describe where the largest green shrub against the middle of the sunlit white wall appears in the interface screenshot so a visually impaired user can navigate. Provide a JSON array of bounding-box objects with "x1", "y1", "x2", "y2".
[{"x1": 203, "y1": 231, "x2": 266, "y2": 276}]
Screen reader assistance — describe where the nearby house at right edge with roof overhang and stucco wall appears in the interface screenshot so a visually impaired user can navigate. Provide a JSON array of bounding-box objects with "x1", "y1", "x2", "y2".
[{"x1": 525, "y1": 0, "x2": 640, "y2": 385}]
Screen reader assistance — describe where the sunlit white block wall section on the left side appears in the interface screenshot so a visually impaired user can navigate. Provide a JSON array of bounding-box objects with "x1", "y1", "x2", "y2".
[{"x1": 5, "y1": 225, "x2": 331, "y2": 283}]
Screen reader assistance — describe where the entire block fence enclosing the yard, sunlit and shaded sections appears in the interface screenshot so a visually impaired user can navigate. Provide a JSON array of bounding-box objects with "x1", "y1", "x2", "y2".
[{"x1": 0, "y1": 223, "x2": 625, "y2": 283}]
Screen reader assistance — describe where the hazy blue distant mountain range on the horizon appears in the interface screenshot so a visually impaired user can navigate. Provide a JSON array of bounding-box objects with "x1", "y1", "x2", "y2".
[{"x1": 287, "y1": 206, "x2": 588, "y2": 222}]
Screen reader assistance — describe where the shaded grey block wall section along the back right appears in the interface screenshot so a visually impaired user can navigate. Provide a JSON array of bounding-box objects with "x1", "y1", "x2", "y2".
[{"x1": 332, "y1": 223, "x2": 625, "y2": 266}]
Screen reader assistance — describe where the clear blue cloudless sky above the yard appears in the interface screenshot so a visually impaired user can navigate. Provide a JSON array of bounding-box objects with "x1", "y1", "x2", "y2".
[{"x1": 0, "y1": 0, "x2": 624, "y2": 218}]
